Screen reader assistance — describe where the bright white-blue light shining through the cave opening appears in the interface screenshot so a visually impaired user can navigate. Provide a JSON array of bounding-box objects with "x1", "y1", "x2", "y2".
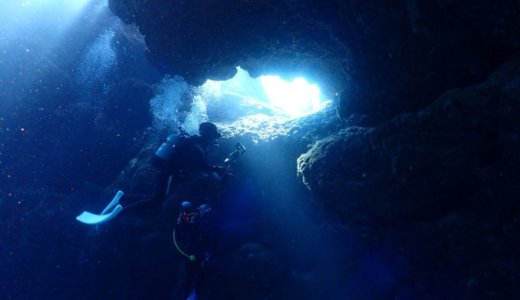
[{"x1": 202, "y1": 68, "x2": 328, "y2": 121}]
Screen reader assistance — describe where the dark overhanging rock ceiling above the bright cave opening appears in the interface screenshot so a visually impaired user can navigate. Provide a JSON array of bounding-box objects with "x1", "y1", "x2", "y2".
[{"x1": 109, "y1": 0, "x2": 520, "y2": 120}]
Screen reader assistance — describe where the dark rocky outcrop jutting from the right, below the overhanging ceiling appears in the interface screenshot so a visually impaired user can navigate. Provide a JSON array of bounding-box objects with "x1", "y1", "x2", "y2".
[{"x1": 298, "y1": 59, "x2": 520, "y2": 299}]
